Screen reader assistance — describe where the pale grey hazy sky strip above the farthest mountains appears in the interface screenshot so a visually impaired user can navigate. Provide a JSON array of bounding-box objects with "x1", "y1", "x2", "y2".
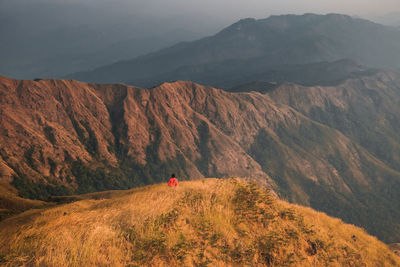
[{"x1": 0, "y1": 0, "x2": 400, "y2": 19}]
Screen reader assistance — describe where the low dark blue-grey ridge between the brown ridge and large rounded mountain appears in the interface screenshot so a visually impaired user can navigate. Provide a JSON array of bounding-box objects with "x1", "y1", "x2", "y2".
[{"x1": 135, "y1": 58, "x2": 377, "y2": 91}]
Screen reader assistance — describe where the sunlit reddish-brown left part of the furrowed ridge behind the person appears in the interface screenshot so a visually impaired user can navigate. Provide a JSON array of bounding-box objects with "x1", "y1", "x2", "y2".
[{"x1": 1, "y1": 75, "x2": 276, "y2": 197}]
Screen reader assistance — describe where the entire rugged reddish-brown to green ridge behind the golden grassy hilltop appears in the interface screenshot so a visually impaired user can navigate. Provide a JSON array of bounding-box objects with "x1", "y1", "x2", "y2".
[{"x1": 0, "y1": 72, "x2": 400, "y2": 242}]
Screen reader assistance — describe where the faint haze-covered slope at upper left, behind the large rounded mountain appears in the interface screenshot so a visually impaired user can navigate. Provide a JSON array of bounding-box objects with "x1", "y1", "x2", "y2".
[{"x1": 0, "y1": 0, "x2": 221, "y2": 79}]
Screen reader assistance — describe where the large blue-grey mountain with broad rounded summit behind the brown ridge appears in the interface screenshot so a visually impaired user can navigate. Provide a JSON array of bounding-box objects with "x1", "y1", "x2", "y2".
[{"x1": 68, "y1": 14, "x2": 400, "y2": 88}]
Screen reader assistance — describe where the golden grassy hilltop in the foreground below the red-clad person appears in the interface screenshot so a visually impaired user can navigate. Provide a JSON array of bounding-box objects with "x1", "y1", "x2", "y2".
[{"x1": 0, "y1": 179, "x2": 400, "y2": 266}]
